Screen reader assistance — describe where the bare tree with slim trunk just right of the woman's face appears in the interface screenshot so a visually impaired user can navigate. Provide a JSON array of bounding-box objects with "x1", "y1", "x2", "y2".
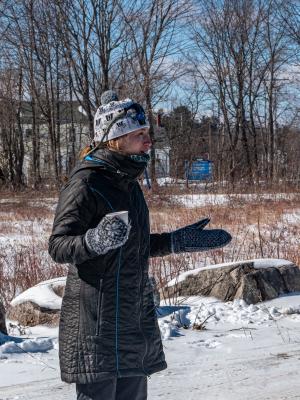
[{"x1": 120, "y1": 0, "x2": 190, "y2": 185}]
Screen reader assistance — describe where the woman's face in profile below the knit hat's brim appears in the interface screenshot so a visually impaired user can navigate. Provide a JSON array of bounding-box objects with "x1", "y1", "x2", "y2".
[{"x1": 120, "y1": 128, "x2": 152, "y2": 154}]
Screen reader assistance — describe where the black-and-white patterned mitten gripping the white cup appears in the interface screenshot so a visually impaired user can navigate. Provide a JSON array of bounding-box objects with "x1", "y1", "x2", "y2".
[{"x1": 85, "y1": 215, "x2": 131, "y2": 255}]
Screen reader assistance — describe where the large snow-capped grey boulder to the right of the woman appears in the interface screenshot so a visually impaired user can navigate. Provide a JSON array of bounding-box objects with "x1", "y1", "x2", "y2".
[{"x1": 164, "y1": 262, "x2": 300, "y2": 304}]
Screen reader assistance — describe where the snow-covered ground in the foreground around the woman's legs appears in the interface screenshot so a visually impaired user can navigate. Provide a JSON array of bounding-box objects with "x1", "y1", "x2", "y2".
[{"x1": 0, "y1": 288, "x2": 300, "y2": 400}]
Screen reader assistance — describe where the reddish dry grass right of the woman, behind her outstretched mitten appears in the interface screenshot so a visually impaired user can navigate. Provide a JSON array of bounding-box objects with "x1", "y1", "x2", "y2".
[{"x1": 150, "y1": 196, "x2": 300, "y2": 302}]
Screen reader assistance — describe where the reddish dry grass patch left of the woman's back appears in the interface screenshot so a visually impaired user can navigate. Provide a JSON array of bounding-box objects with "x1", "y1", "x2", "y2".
[{"x1": 0, "y1": 193, "x2": 66, "y2": 308}]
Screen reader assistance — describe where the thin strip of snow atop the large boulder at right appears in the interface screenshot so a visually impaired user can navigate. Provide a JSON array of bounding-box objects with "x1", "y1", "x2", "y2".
[{"x1": 167, "y1": 258, "x2": 293, "y2": 287}]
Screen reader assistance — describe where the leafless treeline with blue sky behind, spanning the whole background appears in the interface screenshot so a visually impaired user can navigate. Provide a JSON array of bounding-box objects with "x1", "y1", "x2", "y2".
[{"x1": 0, "y1": 0, "x2": 300, "y2": 187}]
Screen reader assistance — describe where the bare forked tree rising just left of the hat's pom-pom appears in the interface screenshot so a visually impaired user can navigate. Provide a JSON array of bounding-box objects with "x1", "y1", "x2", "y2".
[{"x1": 56, "y1": 0, "x2": 123, "y2": 137}]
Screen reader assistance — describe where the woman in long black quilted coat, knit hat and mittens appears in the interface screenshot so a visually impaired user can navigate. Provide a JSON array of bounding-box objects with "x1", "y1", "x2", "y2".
[{"x1": 49, "y1": 91, "x2": 231, "y2": 400}]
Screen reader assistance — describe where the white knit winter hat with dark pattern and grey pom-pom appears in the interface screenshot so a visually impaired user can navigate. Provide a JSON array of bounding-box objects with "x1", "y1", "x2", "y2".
[{"x1": 94, "y1": 90, "x2": 149, "y2": 142}]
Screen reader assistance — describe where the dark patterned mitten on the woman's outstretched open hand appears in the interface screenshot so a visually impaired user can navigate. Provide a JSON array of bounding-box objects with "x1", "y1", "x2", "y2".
[{"x1": 171, "y1": 218, "x2": 232, "y2": 253}]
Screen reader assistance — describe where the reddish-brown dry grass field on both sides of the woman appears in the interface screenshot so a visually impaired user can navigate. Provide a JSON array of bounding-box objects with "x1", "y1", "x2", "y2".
[{"x1": 0, "y1": 189, "x2": 300, "y2": 306}]
